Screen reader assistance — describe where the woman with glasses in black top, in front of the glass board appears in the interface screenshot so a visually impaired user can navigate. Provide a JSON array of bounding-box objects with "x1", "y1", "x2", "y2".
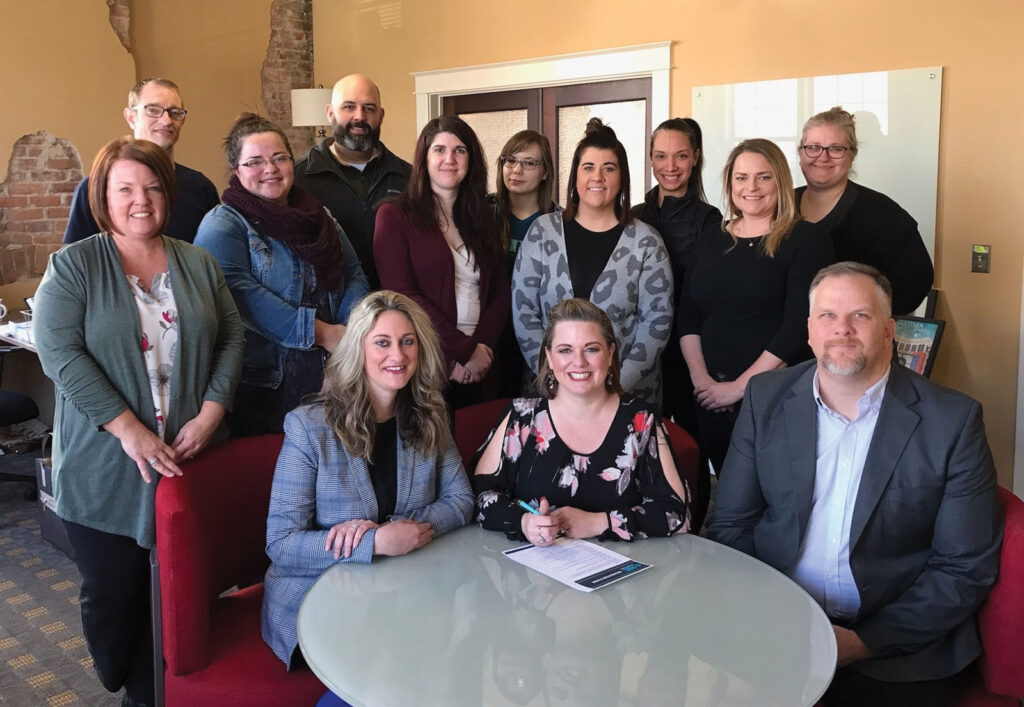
[{"x1": 797, "y1": 106, "x2": 935, "y2": 315}]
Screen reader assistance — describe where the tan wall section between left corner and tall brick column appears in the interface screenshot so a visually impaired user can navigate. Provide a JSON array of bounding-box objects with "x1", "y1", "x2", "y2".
[{"x1": 132, "y1": 0, "x2": 270, "y2": 191}]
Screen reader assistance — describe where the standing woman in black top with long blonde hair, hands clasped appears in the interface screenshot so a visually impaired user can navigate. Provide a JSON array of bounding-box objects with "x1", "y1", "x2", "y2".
[{"x1": 677, "y1": 139, "x2": 833, "y2": 472}]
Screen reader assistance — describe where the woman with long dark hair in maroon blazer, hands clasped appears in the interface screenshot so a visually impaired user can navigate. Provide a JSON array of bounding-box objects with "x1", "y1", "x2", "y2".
[{"x1": 374, "y1": 116, "x2": 511, "y2": 408}]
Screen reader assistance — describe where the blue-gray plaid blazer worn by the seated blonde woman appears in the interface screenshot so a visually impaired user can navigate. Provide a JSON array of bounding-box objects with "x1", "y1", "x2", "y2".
[{"x1": 260, "y1": 405, "x2": 474, "y2": 668}]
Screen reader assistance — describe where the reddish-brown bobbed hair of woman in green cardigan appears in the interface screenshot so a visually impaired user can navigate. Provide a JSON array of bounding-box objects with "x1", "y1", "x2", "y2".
[{"x1": 89, "y1": 135, "x2": 178, "y2": 232}]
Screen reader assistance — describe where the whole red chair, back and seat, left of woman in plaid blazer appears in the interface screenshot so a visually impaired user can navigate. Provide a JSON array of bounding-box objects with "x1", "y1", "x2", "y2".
[{"x1": 154, "y1": 434, "x2": 325, "y2": 707}]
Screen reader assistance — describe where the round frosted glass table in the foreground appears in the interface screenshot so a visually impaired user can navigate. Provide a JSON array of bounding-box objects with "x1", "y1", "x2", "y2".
[{"x1": 298, "y1": 526, "x2": 836, "y2": 707}]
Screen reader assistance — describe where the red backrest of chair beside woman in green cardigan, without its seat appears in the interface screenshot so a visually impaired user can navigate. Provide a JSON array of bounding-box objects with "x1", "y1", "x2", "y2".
[{"x1": 156, "y1": 434, "x2": 284, "y2": 675}]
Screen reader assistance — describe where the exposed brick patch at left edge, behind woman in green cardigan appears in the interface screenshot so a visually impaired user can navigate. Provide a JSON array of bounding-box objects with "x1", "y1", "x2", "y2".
[{"x1": 0, "y1": 131, "x2": 82, "y2": 285}]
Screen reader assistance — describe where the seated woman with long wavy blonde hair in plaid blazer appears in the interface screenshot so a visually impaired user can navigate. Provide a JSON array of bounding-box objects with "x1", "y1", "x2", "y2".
[{"x1": 261, "y1": 290, "x2": 473, "y2": 668}]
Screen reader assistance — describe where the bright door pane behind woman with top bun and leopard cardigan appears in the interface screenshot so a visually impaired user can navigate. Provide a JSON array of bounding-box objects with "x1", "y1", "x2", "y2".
[{"x1": 558, "y1": 100, "x2": 647, "y2": 204}]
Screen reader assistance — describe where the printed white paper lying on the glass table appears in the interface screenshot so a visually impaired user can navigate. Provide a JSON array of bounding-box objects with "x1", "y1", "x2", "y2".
[{"x1": 504, "y1": 538, "x2": 651, "y2": 591}]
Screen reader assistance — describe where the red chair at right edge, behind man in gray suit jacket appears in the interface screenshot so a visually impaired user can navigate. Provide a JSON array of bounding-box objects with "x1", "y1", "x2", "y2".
[{"x1": 954, "y1": 487, "x2": 1024, "y2": 707}]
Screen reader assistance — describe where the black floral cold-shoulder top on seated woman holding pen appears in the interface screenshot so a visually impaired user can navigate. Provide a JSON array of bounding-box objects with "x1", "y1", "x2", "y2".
[{"x1": 471, "y1": 397, "x2": 690, "y2": 541}]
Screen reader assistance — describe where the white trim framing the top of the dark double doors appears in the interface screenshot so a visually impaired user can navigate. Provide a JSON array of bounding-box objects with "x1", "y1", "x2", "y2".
[{"x1": 412, "y1": 41, "x2": 672, "y2": 135}]
